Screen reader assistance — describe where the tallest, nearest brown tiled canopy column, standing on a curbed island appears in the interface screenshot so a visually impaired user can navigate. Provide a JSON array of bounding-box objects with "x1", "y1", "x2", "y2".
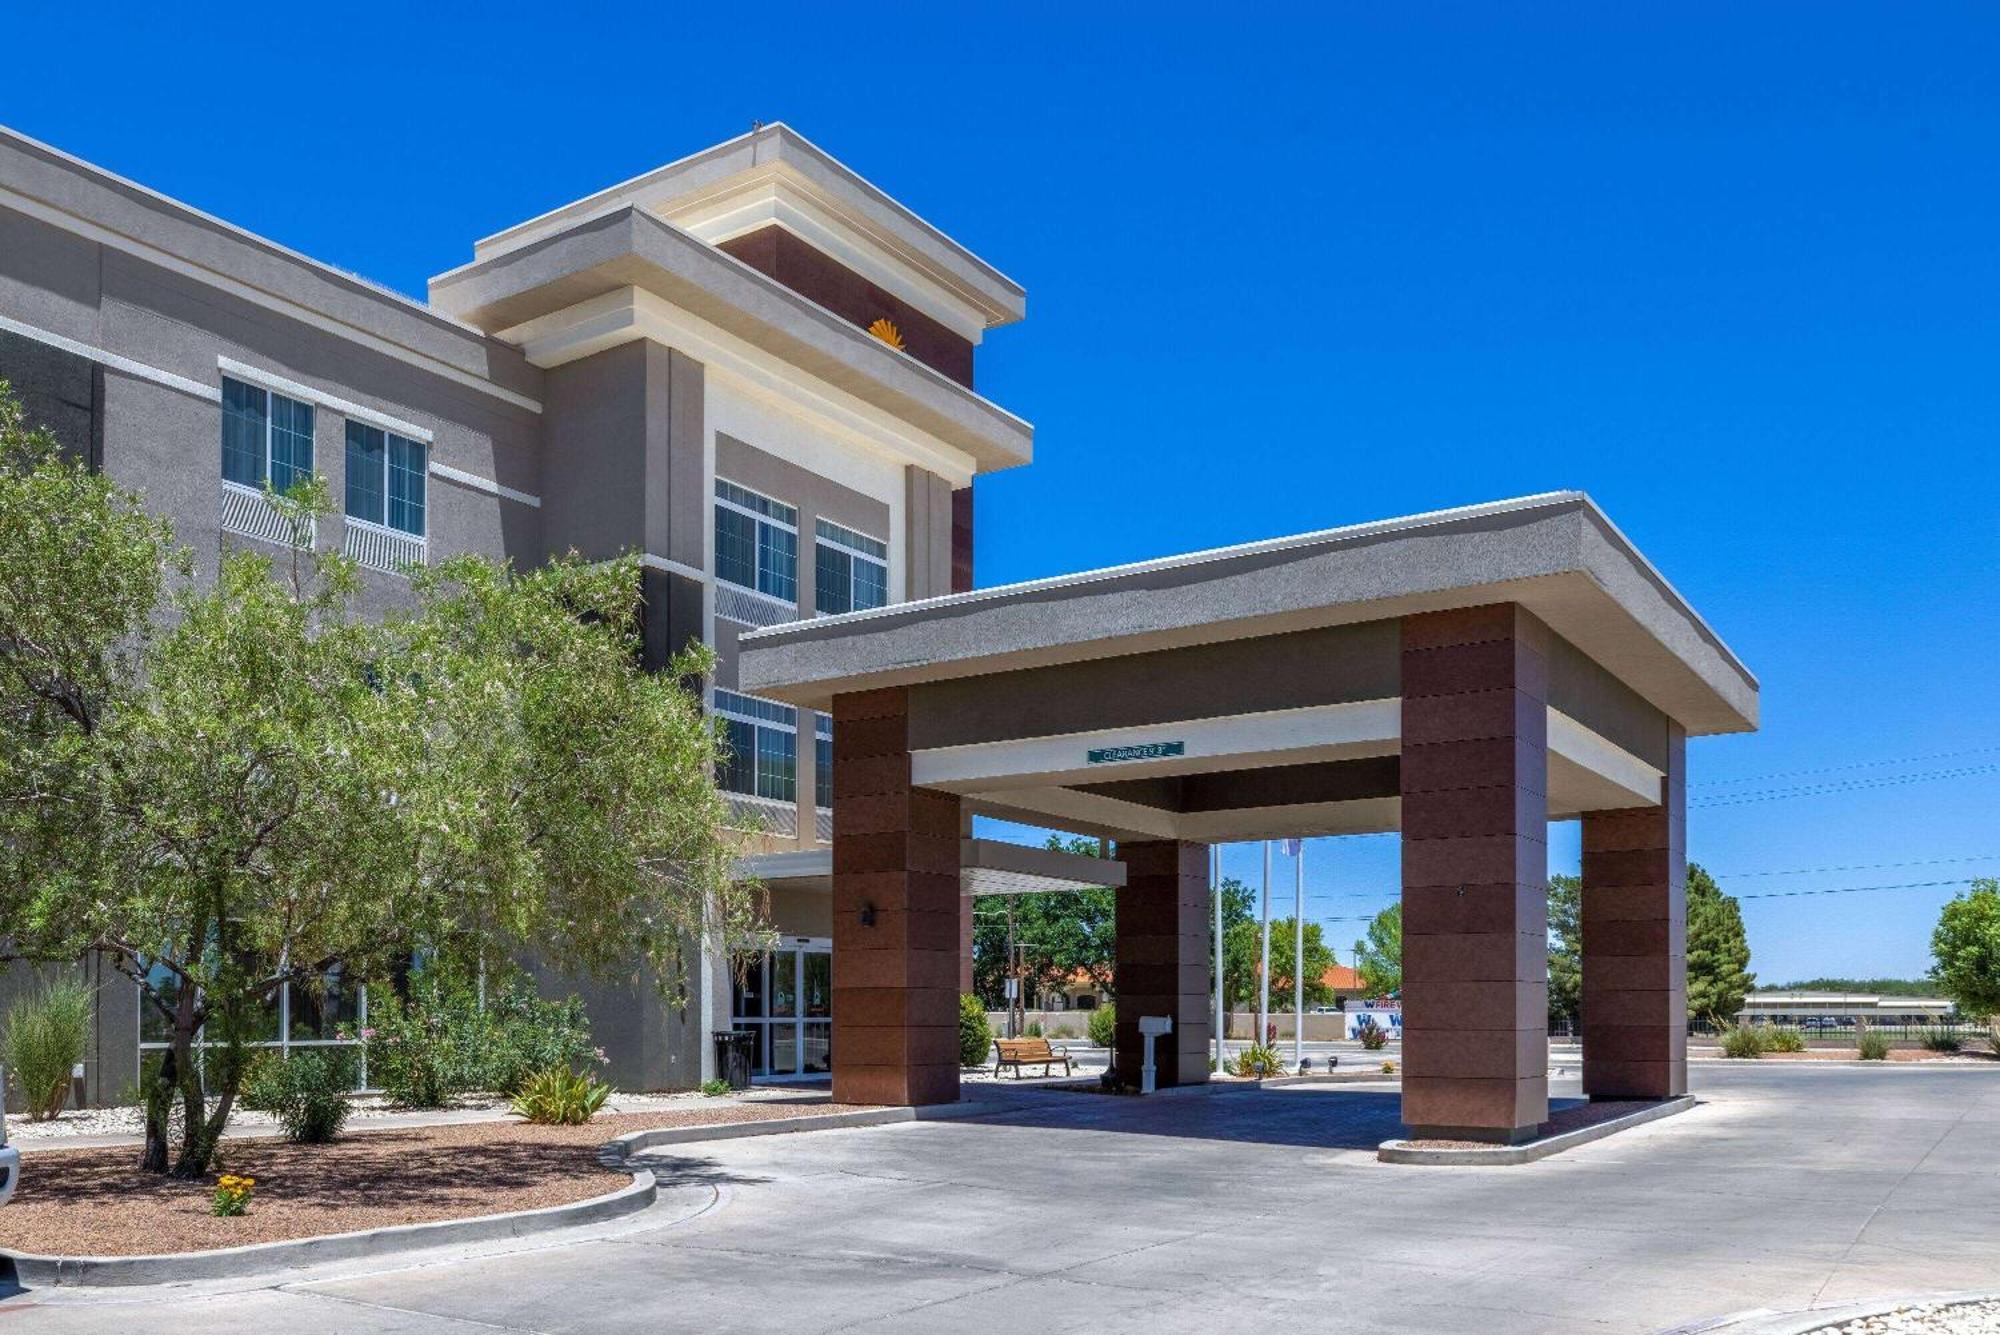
[{"x1": 1402, "y1": 604, "x2": 1548, "y2": 1141}]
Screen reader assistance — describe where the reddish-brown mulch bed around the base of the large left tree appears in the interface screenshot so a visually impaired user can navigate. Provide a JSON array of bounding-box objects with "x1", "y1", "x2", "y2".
[{"x1": 0, "y1": 1101, "x2": 872, "y2": 1257}]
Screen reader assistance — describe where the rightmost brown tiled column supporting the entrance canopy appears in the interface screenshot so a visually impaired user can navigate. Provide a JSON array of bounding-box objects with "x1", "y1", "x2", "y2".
[{"x1": 1582, "y1": 723, "x2": 1688, "y2": 1099}]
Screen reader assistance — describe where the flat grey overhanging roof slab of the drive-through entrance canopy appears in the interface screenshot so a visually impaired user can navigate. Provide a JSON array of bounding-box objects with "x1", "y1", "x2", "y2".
[{"x1": 738, "y1": 492, "x2": 1758, "y2": 735}]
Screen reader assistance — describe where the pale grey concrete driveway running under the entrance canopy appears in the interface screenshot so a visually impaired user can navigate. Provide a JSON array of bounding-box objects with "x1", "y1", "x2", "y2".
[{"x1": 0, "y1": 1063, "x2": 2000, "y2": 1335}]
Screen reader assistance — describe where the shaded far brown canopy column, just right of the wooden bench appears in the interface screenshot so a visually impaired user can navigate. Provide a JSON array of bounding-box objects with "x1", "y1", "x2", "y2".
[{"x1": 1112, "y1": 839, "x2": 1214, "y2": 1089}]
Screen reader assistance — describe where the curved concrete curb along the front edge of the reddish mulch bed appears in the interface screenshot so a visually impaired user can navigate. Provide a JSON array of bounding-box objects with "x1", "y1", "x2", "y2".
[{"x1": 0, "y1": 1169, "x2": 658, "y2": 1287}]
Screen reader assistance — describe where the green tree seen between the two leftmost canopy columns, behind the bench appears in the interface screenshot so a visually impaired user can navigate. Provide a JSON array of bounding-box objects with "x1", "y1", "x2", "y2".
[{"x1": 972, "y1": 835, "x2": 1118, "y2": 1005}]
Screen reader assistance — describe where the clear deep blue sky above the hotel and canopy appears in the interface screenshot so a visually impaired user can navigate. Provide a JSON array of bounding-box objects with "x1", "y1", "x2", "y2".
[{"x1": 0, "y1": 4, "x2": 2000, "y2": 981}]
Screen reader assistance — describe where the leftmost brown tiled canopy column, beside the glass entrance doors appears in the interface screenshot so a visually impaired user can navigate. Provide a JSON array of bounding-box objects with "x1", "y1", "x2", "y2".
[{"x1": 834, "y1": 687, "x2": 960, "y2": 1103}]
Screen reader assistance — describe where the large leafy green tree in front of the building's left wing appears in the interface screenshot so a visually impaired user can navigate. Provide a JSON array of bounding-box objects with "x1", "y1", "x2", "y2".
[{"x1": 0, "y1": 396, "x2": 756, "y2": 1177}]
